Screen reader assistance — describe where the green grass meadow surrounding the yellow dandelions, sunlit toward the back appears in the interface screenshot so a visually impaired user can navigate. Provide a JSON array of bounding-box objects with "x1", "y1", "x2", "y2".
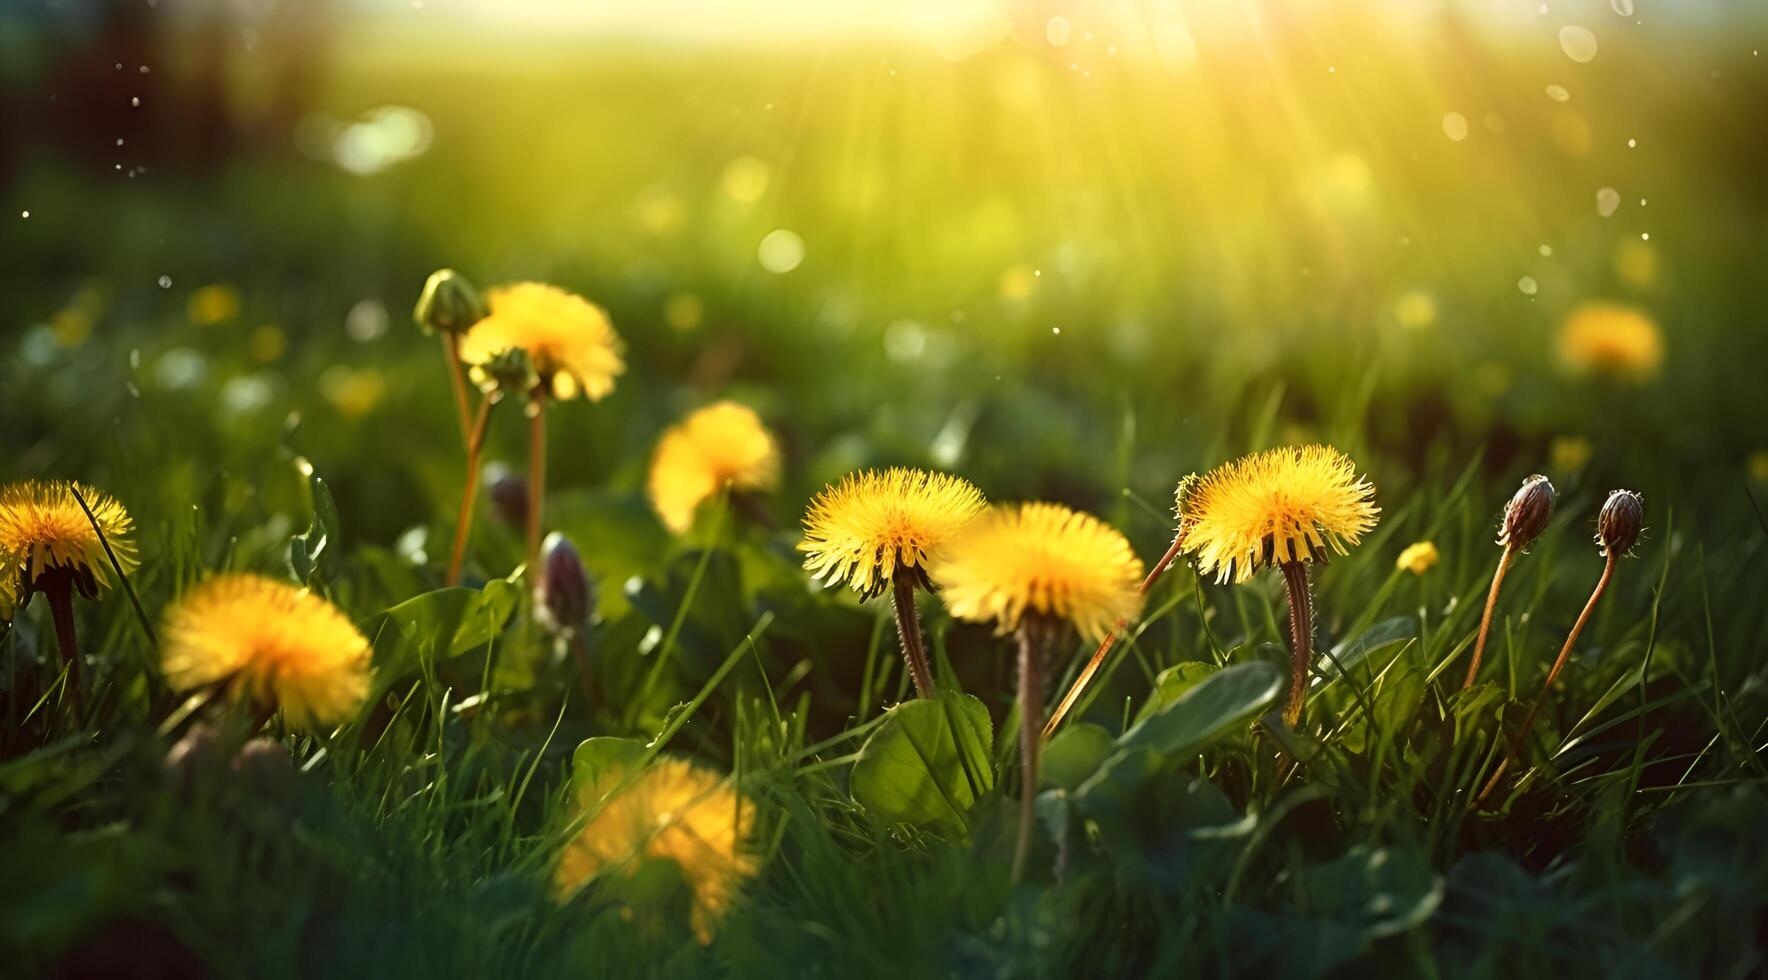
[{"x1": 0, "y1": 15, "x2": 1768, "y2": 980}]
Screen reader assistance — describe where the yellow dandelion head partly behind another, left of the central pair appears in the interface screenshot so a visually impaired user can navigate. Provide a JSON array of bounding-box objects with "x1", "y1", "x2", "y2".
[{"x1": 797, "y1": 467, "x2": 985, "y2": 598}]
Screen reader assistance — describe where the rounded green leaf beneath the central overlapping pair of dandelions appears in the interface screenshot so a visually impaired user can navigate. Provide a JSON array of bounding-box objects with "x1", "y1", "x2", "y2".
[{"x1": 850, "y1": 692, "x2": 994, "y2": 830}]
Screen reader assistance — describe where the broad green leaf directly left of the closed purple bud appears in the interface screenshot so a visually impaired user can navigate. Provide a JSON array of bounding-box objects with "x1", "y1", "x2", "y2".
[{"x1": 373, "y1": 578, "x2": 520, "y2": 690}]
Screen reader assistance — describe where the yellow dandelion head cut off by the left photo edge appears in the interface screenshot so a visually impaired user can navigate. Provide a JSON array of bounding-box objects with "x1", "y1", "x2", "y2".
[{"x1": 0, "y1": 479, "x2": 136, "y2": 603}]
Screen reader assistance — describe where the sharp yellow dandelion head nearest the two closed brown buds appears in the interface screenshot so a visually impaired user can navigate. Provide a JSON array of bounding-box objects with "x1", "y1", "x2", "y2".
[{"x1": 1185, "y1": 446, "x2": 1381, "y2": 582}]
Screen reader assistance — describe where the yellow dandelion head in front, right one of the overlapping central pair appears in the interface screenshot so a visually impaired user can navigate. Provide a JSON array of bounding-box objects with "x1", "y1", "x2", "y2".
[{"x1": 930, "y1": 504, "x2": 1142, "y2": 640}]
